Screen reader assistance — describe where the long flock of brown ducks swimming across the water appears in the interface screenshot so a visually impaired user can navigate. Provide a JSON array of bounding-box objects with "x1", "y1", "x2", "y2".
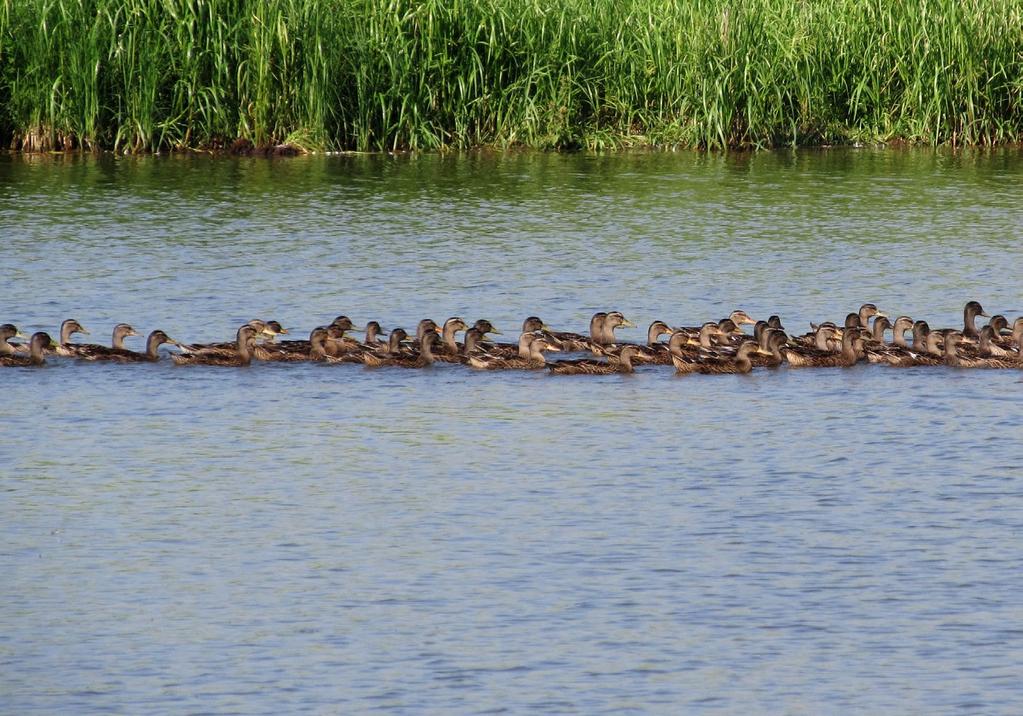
[{"x1": 0, "y1": 301, "x2": 1023, "y2": 375}]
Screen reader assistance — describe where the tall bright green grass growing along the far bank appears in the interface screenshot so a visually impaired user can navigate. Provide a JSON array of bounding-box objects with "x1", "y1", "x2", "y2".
[{"x1": 0, "y1": 0, "x2": 1023, "y2": 151}]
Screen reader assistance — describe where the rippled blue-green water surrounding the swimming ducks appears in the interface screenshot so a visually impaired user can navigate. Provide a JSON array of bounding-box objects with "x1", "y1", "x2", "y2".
[{"x1": 0, "y1": 150, "x2": 1023, "y2": 714}]
